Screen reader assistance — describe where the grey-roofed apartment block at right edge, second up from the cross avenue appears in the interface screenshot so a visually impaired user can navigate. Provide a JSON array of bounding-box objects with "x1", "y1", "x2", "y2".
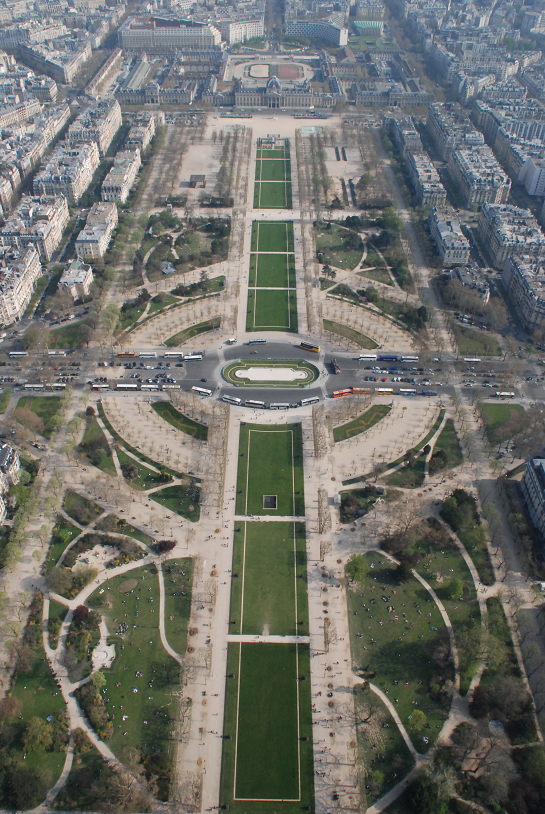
[{"x1": 479, "y1": 203, "x2": 545, "y2": 271}]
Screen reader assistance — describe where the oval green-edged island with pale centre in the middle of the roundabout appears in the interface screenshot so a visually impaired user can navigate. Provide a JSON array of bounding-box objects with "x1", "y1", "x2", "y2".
[{"x1": 222, "y1": 359, "x2": 320, "y2": 387}]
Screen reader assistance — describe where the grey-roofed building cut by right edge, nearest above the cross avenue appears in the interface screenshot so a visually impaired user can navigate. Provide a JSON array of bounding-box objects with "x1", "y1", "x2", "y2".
[{"x1": 501, "y1": 256, "x2": 545, "y2": 331}]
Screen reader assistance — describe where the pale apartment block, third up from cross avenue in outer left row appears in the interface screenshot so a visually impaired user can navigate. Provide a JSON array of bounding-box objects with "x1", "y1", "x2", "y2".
[{"x1": 33, "y1": 141, "x2": 100, "y2": 204}]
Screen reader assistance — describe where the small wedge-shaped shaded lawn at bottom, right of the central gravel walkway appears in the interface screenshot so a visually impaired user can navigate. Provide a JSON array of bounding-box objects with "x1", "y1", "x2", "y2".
[{"x1": 355, "y1": 685, "x2": 414, "y2": 806}]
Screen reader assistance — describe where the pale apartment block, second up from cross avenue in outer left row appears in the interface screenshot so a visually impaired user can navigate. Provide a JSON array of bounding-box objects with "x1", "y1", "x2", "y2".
[{"x1": 0, "y1": 195, "x2": 69, "y2": 263}]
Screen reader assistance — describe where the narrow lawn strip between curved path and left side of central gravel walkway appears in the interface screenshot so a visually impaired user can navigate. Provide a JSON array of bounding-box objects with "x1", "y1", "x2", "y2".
[{"x1": 163, "y1": 557, "x2": 193, "y2": 656}]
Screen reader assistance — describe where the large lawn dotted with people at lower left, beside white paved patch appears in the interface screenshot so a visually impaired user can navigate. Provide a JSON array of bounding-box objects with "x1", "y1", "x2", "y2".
[{"x1": 87, "y1": 565, "x2": 180, "y2": 784}]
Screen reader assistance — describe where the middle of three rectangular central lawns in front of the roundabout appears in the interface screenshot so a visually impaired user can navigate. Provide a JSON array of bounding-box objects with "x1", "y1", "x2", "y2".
[{"x1": 229, "y1": 521, "x2": 309, "y2": 636}]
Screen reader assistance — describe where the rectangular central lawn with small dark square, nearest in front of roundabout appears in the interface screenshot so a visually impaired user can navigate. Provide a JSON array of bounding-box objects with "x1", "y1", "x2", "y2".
[{"x1": 236, "y1": 424, "x2": 305, "y2": 517}]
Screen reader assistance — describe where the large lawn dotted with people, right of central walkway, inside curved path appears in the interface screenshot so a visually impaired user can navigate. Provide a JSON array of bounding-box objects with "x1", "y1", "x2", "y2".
[{"x1": 347, "y1": 553, "x2": 454, "y2": 752}]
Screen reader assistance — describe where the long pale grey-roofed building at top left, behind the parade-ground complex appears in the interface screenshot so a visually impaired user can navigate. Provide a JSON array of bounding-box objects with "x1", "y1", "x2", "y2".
[{"x1": 117, "y1": 16, "x2": 221, "y2": 51}]
